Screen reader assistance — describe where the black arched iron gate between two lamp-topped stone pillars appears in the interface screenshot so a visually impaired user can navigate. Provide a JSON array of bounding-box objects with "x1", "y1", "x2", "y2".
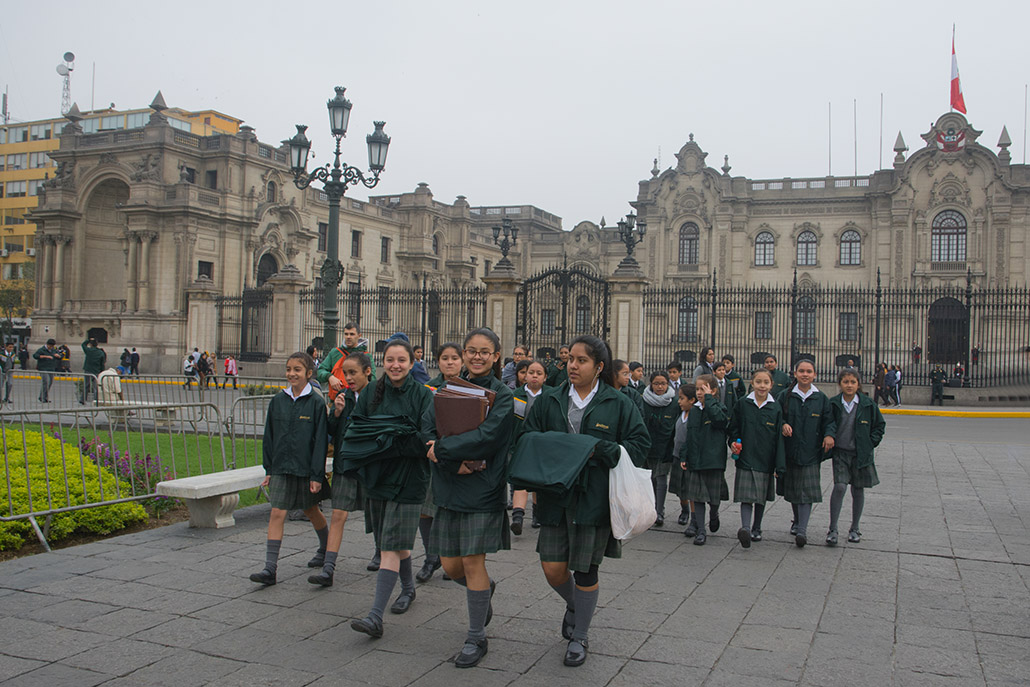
[{"x1": 515, "y1": 264, "x2": 611, "y2": 357}]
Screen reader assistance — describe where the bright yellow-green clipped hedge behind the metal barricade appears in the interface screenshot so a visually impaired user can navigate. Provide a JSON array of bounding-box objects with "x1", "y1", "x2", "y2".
[{"x1": 0, "y1": 426, "x2": 147, "y2": 551}]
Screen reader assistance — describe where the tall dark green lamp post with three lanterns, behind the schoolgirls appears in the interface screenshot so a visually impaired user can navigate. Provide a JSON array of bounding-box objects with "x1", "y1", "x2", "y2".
[{"x1": 283, "y1": 85, "x2": 390, "y2": 352}]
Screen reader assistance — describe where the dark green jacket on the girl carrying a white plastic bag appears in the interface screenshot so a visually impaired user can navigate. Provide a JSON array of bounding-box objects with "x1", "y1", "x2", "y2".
[{"x1": 523, "y1": 381, "x2": 651, "y2": 526}]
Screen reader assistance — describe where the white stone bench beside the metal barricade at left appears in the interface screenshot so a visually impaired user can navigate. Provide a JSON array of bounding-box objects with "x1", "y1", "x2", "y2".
[{"x1": 155, "y1": 457, "x2": 333, "y2": 528}]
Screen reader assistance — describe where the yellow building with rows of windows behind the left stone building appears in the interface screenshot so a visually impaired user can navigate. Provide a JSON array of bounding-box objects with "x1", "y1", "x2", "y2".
[{"x1": 0, "y1": 102, "x2": 242, "y2": 284}]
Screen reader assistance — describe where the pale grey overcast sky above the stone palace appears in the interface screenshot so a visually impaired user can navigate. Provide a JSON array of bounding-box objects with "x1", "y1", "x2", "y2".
[{"x1": 0, "y1": 0, "x2": 1030, "y2": 230}]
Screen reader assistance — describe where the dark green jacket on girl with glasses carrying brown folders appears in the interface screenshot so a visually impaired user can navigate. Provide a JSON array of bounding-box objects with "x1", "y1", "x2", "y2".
[{"x1": 422, "y1": 375, "x2": 515, "y2": 513}]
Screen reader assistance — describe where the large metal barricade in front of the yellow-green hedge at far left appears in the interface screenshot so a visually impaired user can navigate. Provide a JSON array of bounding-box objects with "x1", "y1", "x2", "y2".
[{"x1": 0, "y1": 402, "x2": 227, "y2": 550}]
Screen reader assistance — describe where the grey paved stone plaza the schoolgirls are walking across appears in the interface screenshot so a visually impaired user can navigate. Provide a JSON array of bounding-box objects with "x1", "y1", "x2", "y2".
[{"x1": 0, "y1": 415, "x2": 1030, "y2": 687}]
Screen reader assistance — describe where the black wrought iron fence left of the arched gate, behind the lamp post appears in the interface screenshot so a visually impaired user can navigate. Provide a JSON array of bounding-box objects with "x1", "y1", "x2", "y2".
[{"x1": 300, "y1": 279, "x2": 486, "y2": 367}]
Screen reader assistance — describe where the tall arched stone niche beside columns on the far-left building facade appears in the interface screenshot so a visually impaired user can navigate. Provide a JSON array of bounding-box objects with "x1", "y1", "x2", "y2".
[{"x1": 78, "y1": 179, "x2": 129, "y2": 301}]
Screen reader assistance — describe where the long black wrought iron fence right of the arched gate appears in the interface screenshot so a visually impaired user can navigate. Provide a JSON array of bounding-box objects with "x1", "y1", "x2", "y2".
[{"x1": 642, "y1": 271, "x2": 1030, "y2": 387}]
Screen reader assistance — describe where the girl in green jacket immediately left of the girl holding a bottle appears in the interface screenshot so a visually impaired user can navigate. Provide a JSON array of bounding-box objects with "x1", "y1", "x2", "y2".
[{"x1": 680, "y1": 375, "x2": 729, "y2": 546}]
